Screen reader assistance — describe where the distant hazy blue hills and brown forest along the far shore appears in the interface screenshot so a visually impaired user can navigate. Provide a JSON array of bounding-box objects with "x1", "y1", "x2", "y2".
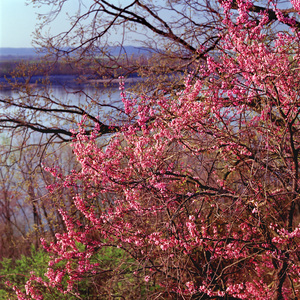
[{"x1": 0, "y1": 46, "x2": 151, "y2": 79}]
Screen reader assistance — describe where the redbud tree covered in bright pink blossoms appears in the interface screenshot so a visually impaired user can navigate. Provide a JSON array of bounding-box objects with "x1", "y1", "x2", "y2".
[{"x1": 16, "y1": 0, "x2": 300, "y2": 299}]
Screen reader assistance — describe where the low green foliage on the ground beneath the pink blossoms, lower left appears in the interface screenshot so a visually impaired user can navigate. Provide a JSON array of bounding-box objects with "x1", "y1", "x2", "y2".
[{"x1": 0, "y1": 246, "x2": 153, "y2": 300}]
